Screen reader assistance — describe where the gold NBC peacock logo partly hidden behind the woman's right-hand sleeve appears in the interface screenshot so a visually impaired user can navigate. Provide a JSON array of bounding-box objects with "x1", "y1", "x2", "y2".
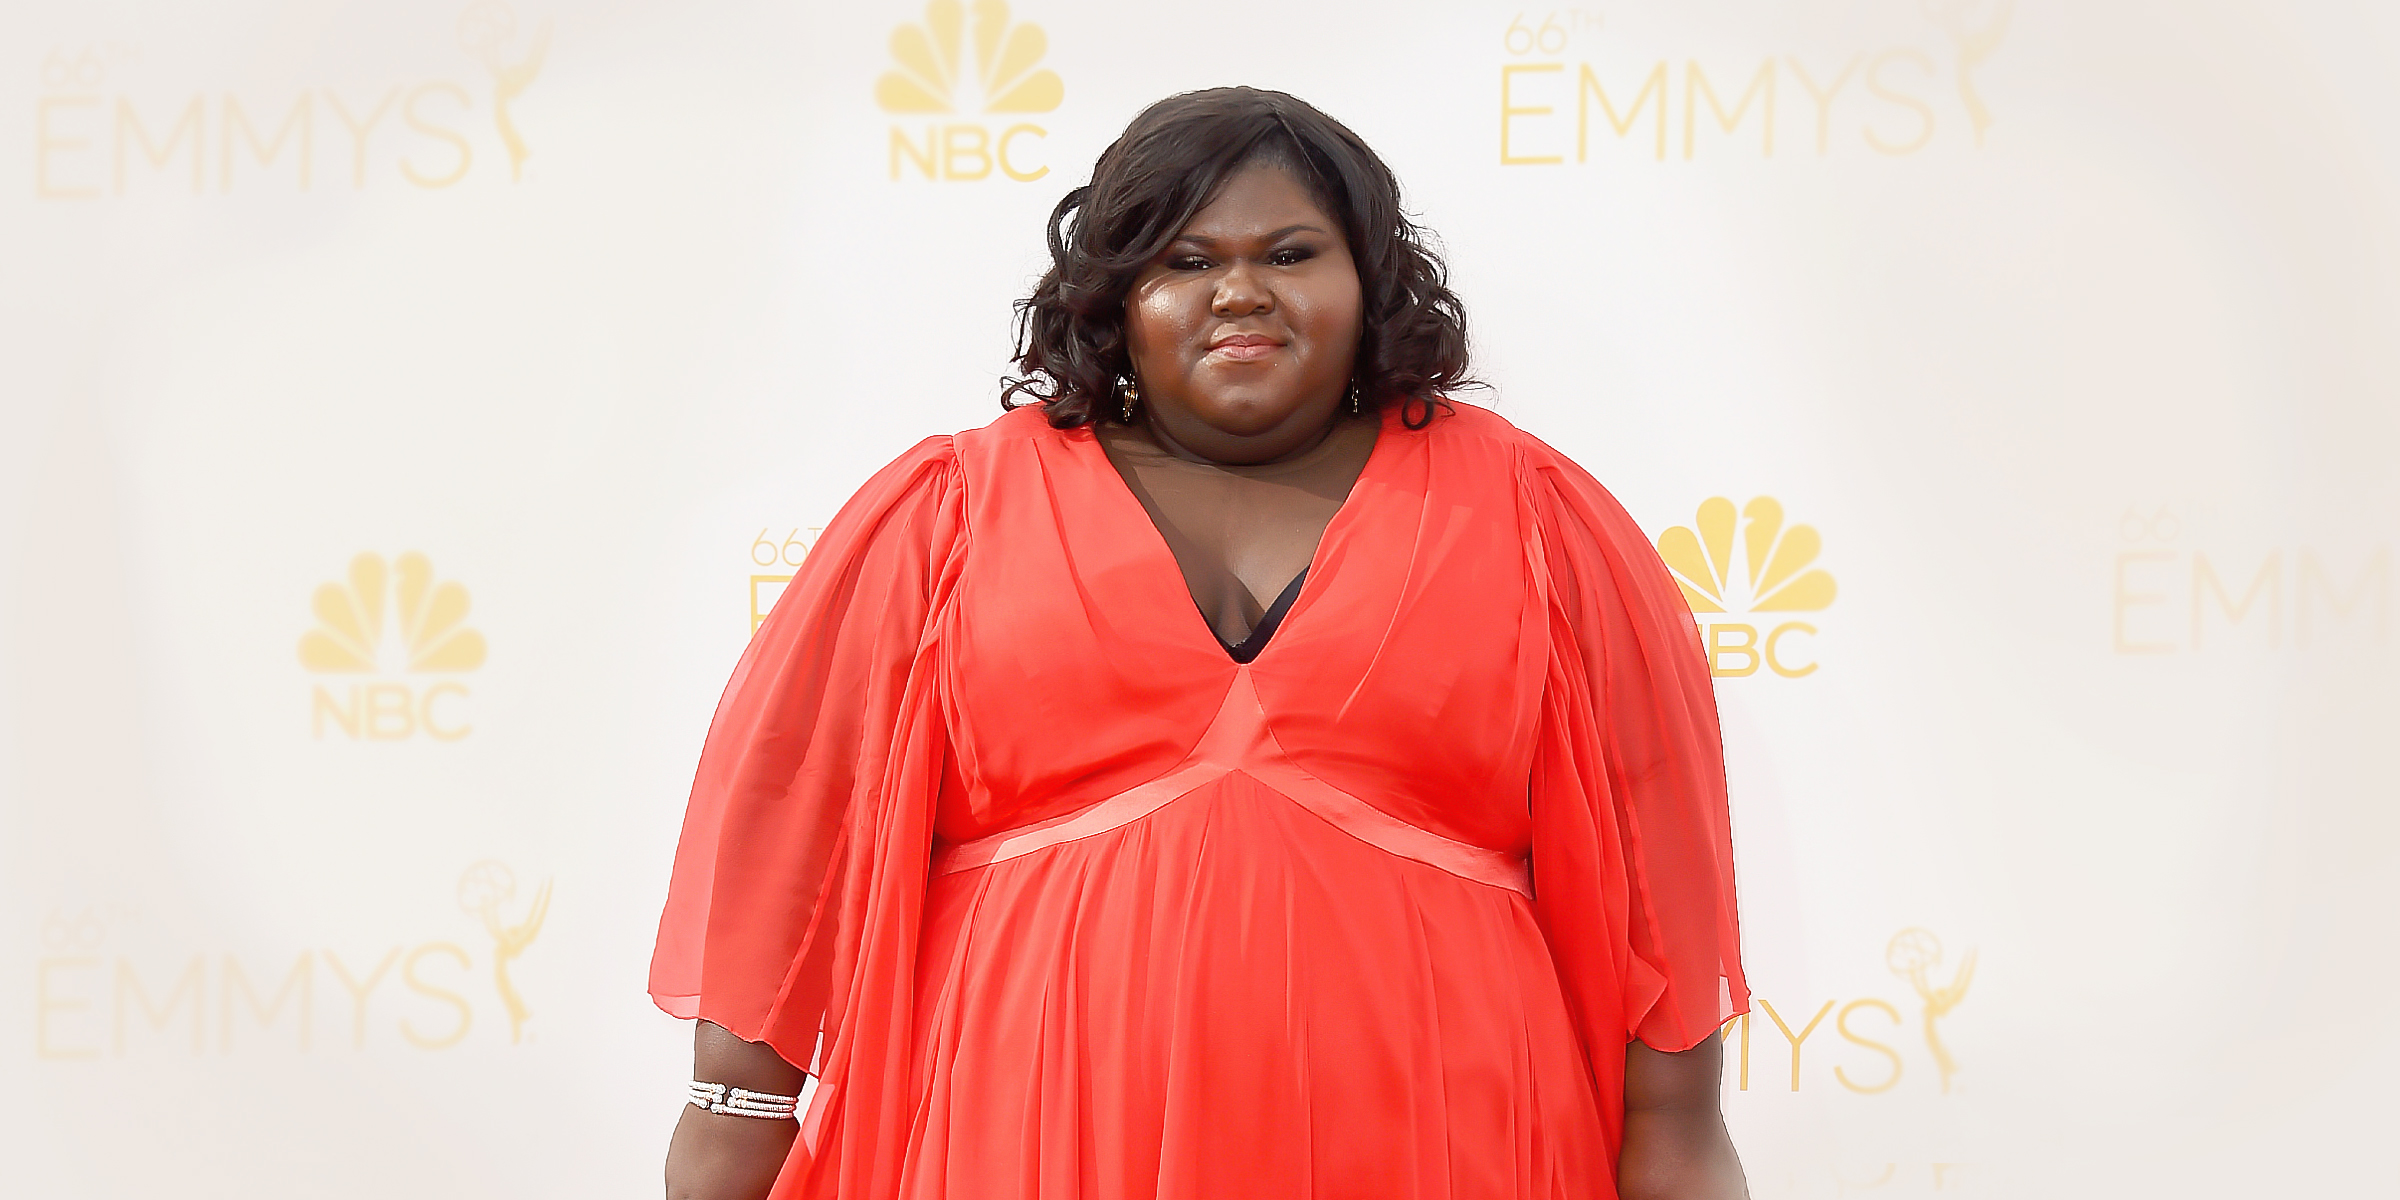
[{"x1": 1658, "y1": 497, "x2": 1834, "y2": 679}]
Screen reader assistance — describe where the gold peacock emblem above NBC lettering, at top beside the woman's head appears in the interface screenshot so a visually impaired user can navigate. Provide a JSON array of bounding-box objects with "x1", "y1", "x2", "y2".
[{"x1": 876, "y1": 0, "x2": 1066, "y2": 113}]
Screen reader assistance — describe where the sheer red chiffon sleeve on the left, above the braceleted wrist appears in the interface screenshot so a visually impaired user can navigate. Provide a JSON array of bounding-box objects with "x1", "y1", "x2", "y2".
[{"x1": 650, "y1": 437, "x2": 962, "y2": 1073}]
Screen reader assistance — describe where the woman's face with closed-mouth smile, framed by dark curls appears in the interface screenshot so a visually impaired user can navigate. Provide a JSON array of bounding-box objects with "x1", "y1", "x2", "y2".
[{"x1": 1126, "y1": 163, "x2": 1361, "y2": 463}]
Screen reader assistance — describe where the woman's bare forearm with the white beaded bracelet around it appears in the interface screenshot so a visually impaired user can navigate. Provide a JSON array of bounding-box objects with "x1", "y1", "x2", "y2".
[{"x1": 667, "y1": 1020, "x2": 806, "y2": 1200}]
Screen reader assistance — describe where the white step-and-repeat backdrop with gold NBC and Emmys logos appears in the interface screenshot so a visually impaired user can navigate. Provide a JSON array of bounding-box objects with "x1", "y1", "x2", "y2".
[{"x1": 0, "y1": 0, "x2": 2400, "y2": 1200}]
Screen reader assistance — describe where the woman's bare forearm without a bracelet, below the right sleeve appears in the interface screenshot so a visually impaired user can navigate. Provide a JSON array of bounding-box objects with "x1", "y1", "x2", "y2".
[{"x1": 1618, "y1": 1037, "x2": 1750, "y2": 1200}]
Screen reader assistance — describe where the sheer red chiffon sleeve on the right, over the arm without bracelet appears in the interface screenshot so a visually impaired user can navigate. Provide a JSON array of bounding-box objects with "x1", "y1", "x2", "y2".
[{"x1": 1519, "y1": 439, "x2": 1750, "y2": 1060}]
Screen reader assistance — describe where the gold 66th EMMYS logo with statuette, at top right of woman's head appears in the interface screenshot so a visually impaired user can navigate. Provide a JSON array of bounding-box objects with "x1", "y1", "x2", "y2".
[{"x1": 1500, "y1": 0, "x2": 2014, "y2": 166}]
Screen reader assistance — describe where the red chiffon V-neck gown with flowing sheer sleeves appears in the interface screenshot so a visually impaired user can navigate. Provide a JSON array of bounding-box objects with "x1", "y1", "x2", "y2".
[{"x1": 650, "y1": 403, "x2": 1747, "y2": 1200}]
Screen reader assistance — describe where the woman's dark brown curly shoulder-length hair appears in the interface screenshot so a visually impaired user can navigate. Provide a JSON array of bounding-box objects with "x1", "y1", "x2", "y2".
[{"x1": 1001, "y1": 86, "x2": 1478, "y2": 430}]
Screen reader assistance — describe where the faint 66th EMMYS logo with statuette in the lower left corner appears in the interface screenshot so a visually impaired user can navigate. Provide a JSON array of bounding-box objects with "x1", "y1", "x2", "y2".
[{"x1": 31, "y1": 862, "x2": 550, "y2": 1061}]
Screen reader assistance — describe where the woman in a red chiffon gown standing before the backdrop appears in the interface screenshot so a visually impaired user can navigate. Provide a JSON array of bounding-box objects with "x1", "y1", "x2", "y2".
[{"x1": 650, "y1": 89, "x2": 1747, "y2": 1200}]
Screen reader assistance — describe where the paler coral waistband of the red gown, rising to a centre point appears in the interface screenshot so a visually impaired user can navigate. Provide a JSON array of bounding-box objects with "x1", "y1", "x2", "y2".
[{"x1": 934, "y1": 667, "x2": 1534, "y2": 898}]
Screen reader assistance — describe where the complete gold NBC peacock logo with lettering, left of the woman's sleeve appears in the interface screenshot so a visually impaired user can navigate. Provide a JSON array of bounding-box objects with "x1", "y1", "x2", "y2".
[{"x1": 300, "y1": 550, "x2": 485, "y2": 742}]
